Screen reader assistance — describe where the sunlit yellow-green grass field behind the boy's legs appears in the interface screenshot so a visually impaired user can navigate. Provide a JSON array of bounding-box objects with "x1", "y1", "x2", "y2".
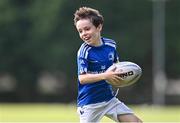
[{"x1": 0, "y1": 103, "x2": 180, "y2": 122}]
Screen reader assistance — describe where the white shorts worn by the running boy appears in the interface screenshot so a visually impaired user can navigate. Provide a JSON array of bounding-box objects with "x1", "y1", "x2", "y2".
[{"x1": 77, "y1": 97, "x2": 133, "y2": 123}]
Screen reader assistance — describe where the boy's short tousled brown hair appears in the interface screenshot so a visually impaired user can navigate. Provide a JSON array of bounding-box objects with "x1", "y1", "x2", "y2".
[{"x1": 74, "y1": 7, "x2": 104, "y2": 27}]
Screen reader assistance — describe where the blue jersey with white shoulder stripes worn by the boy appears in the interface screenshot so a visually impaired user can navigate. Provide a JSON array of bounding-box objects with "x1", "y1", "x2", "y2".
[{"x1": 77, "y1": 38, "x2": 118, "y2": 106}]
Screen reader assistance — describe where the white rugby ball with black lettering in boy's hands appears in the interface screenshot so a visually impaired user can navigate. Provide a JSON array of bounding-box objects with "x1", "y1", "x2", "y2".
[{"x1": 105, "y1": 61, "x2": 142, "y2": 87}]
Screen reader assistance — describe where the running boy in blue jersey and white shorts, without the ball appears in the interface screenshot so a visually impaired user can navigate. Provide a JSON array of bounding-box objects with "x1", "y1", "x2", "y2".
[{"x1": 74, "y1": 7, "x2": 141, "y2": 123}]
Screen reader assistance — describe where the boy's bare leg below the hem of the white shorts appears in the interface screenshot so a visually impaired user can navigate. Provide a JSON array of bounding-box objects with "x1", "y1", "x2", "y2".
[{"x1": 118, "y1": 114, "x2": 142, "y2": 123}]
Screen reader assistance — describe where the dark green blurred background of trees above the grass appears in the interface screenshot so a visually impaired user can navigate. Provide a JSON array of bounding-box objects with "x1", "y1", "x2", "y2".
[{"x1": 0, "y1": 0, "x2": 180, "y2": 121}]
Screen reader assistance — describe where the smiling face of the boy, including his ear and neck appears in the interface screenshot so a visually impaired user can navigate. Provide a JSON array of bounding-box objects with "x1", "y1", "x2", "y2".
[{"x1": 76, "y1": 19, "x2": 102, "y2": 46}]
